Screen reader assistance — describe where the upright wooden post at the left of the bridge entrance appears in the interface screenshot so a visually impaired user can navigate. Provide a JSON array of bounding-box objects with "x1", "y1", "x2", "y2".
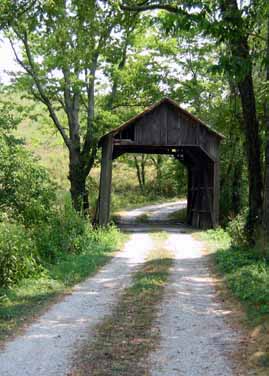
[{"x1": 97, "y1": 135, "x2": 113, "y2": 226}]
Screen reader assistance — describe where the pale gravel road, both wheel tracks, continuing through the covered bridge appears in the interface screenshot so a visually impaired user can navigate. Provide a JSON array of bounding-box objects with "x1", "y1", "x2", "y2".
[{"x1": 0, "y1": 201, "x2": 241, "y2": 376}]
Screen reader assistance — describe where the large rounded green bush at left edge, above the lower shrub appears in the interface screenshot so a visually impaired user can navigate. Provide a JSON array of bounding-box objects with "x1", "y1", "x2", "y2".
[{"x1": 0, "y1": 132, "x2": 55, "y2": 226}]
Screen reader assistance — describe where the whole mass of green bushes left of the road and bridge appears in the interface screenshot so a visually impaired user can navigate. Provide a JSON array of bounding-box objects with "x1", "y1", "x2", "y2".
[{"x1": 0, "y1": 101, "x2": 118, "y2": 286}]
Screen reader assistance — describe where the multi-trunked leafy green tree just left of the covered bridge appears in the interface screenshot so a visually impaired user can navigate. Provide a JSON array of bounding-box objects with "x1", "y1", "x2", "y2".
[{"x1": 6, "y1": 0, "x2": 128, "y2": 212}]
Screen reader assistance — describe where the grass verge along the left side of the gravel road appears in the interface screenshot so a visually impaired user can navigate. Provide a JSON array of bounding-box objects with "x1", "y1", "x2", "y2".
[{"x1": 0, "y1": 231, "x2": 127, "y2": 341}]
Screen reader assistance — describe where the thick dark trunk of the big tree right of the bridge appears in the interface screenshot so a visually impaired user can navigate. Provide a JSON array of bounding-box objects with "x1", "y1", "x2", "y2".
[{"x1": 220, "y1": 0, "x2": 263, "y2": 241}]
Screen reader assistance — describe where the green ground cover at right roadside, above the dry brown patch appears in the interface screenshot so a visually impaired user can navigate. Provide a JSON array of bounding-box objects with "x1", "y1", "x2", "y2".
[{"x1": 203, "y1": 229, "x2": 269, "y2": 322}]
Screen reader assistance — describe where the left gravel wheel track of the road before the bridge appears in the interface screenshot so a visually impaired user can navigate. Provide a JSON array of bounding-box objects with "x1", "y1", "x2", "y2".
[{"x1": 0, "y1": 233, "x2": 152, "y2": 376}]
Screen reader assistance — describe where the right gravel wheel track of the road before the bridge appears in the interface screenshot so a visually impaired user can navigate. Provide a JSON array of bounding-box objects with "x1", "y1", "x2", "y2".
[{"x1": 150, "y1": 233, "x2": 240, "y2": 376}]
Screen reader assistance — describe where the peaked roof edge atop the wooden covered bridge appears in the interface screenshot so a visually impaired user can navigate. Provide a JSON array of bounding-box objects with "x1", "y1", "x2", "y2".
[{"x1": 99, "y1": 97, "x2": 225, "y2": 145}]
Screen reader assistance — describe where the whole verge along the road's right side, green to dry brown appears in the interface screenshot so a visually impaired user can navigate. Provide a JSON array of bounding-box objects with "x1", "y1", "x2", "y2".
[{"x1": 196, "y1": 229, "x2": 269, "y2": 376}]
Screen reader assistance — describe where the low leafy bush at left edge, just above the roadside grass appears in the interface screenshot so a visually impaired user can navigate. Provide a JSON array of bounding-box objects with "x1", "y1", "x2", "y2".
[{"x1": 0, "y1": 223, "x2": 41, "y2": 287}]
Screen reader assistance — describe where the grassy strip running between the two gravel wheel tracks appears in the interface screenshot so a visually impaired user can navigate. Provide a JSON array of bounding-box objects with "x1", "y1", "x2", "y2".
[{"x1": 70, "y1": 245, "x2": 173, "y2": 376}]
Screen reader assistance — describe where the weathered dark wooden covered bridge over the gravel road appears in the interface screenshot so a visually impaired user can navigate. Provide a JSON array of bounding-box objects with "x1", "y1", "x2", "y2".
[{"x1": 97, "y1": 98, "x2": 223, "y2": 228}]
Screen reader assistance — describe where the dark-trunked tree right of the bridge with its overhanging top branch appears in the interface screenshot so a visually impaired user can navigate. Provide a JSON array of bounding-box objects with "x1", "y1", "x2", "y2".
[{"x1": 122, "y1": 0, "x2": 263, "y2": 240}]
